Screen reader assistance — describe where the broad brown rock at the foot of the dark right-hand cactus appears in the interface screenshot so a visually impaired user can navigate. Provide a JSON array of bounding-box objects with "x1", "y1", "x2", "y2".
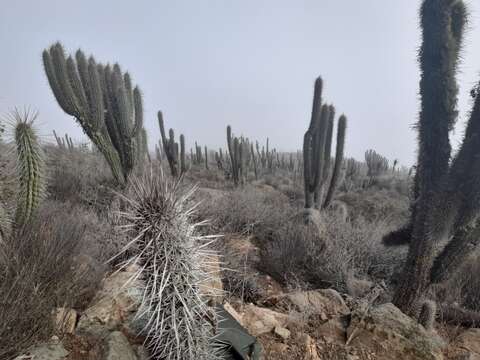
[{"x1": 347, "y1": 303, "x2": 445, "y2": 360}]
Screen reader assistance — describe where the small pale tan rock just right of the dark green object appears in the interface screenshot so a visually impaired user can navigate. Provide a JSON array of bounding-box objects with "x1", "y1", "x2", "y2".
[{"x1": 241, "y1": 304, "x2": 288, "y2": 336}]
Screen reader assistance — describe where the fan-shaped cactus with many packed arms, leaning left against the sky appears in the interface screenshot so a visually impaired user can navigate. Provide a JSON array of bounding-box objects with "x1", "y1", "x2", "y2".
[{"x1": 43, "y1": 43, "x2": 143, "y2": 185}]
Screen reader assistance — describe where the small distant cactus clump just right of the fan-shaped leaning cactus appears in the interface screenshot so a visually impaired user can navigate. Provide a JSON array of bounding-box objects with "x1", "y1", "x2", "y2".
[{"x1": 157, "y1": 111, "x2": 187, "y2": 177}]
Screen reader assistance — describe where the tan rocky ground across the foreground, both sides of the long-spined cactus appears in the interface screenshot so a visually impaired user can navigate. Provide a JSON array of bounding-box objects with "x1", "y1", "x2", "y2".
[{"x1": 17, "y1": 235, "x2": 480, "y2": 360}]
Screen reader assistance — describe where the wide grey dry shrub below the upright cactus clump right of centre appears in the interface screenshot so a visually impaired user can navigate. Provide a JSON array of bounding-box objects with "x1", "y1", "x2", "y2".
[{"x1": 261, "y1": 212, "x2": 404, "y2": 291}]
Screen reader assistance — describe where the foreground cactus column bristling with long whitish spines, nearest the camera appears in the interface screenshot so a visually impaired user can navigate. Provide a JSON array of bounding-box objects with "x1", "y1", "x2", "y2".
[{"x1": 115, "y1": 171, "x2": 223, "y2": 360}]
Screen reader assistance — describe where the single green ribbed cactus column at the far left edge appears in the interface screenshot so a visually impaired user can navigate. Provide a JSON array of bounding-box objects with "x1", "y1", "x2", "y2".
[{"x1": 11, "y1": 110, "x2": 45, "y2": 227}]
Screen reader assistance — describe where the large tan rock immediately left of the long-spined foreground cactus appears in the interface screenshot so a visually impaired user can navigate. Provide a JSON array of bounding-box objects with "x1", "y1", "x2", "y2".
[{"x1": 77, "y1": 267, "x2": 142, "y2": 331}]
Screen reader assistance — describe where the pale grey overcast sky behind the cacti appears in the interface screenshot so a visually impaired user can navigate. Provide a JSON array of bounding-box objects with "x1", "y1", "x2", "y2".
[{"x1": 0, "y1": 0, "x2": 480, "y2": 164}]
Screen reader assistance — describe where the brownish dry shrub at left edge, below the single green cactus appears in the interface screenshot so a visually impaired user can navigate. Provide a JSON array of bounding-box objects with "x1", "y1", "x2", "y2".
[{"x1": 0, "y1": 202, "x2": 103, "y2": 359}]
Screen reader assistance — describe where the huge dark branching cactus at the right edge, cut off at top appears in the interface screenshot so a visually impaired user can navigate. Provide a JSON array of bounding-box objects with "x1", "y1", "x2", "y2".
[{"x1": 393, "y1": 0, "x2": 468, "y2": 316}]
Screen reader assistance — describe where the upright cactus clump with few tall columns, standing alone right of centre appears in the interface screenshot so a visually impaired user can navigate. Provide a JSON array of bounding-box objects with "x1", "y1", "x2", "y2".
[{"x1": 303, "y1": 77, "x2": 347, "y2": 209}]
